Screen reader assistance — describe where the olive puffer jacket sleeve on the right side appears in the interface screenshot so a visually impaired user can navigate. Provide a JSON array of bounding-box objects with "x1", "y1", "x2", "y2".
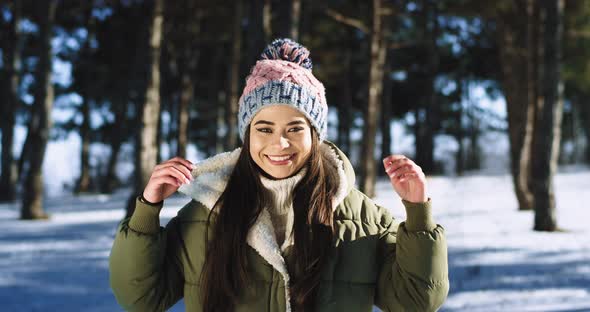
[{"x1": 375, "y1": 199, "x2": 449, "y2": 312}]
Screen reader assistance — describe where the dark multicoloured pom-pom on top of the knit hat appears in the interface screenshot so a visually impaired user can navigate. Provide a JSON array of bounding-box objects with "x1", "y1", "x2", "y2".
[{"x1": 260, "y1": 38, "x2": 313, "y2": 70}]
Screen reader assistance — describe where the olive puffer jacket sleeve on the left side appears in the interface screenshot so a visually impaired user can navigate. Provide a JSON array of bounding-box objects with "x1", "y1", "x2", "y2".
[{"x1": 109, "y1": 200, "x2": 184, "y2": 311}]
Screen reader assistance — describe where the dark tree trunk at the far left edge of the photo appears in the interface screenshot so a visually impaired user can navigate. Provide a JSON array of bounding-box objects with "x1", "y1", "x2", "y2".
[{"x1": 0, "y1": 0, "x2": 21, "y2": 202}]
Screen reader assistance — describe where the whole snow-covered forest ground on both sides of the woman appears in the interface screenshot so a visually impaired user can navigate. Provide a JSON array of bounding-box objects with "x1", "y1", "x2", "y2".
[{"x1": 0, "y1": 167, "x2": 590, "y2": 312}]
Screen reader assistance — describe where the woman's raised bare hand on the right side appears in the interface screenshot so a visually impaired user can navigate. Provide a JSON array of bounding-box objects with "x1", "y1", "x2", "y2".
[{"x1": 383, "y1": 155, "x2": 428, "y2": 203}]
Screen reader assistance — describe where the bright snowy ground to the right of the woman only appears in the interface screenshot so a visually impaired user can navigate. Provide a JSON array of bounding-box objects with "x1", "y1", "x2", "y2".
[{"x1": 376, "y1": 168, "x2": 590, "y2": 312}]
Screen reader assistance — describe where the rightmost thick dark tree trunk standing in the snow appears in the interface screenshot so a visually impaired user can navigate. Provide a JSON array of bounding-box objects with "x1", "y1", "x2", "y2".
[{"x1": 532, "y1": 0, "x2": 563, "y2": 231}]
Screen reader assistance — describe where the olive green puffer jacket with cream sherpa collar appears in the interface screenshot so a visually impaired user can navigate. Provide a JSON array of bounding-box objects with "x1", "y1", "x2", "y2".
[{"x1": 109, "y1": 142, "x2": 449, "y2": 312}]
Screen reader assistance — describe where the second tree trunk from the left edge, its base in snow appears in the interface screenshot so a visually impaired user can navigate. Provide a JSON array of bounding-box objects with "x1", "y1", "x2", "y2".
[{"x1": 21, "y1": 0, "x2": 57, "y2": 220}]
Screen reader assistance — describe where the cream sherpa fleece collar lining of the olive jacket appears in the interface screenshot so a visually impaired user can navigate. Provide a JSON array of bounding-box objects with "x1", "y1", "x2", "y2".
[{"x1": 178, "y1": 144, "x2": 354, "y2": 312}]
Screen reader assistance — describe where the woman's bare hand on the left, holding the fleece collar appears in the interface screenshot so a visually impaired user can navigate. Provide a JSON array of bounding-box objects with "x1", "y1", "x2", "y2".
[{"x1": 143, "y1": 157, "x2": 194, "y2": 203}]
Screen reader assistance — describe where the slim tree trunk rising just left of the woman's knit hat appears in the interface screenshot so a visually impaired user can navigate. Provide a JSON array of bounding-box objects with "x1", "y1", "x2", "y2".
[{"x1": 225, "y1": 0, "x2": 243, "y2": 150}]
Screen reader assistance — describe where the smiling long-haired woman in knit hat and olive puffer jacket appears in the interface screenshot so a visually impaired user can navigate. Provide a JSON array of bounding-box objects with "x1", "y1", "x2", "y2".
[{"x1": 110, "y1": 39, "x2": 449, "y2": 311}]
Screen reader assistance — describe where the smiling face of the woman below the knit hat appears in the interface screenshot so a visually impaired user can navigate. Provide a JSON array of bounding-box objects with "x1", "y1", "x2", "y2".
[{"x1": 250, "y1": 105, "x2": 312, "y2": 179}]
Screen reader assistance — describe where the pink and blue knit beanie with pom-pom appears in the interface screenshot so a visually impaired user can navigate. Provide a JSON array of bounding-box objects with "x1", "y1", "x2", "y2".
[{"x1": 238, "y1": 38, "x2": 328, "y2": 142}]
